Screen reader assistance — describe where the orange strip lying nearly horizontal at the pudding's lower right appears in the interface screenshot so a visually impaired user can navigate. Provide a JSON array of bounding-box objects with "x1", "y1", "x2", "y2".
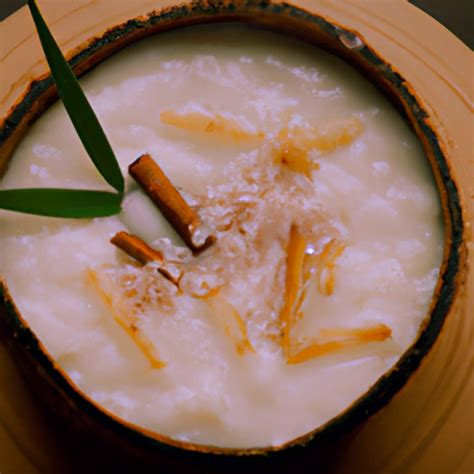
[{"x1": 287, "y1": 324, "x2": 392, "y2": 364}]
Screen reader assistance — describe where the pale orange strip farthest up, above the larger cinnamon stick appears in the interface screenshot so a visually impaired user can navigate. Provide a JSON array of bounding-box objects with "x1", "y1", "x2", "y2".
[{"x1": 160, "y1": 104, "x2": 264, "y2": 142}]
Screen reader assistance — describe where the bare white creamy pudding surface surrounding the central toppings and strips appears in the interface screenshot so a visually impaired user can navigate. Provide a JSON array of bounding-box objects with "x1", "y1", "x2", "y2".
[{"x1": 0, "y1": 26, "x2": 443, "y2": 447}]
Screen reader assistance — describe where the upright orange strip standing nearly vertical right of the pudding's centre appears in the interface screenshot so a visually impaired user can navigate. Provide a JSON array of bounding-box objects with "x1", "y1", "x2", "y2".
[{"x1": 280, "y1": 224, "x2": 306, "y2": 357}]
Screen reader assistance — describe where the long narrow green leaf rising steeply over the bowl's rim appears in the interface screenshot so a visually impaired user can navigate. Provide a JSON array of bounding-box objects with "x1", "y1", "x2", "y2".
[{"x1": 28, "y1": 0, "x2": 124, "y2": 192}]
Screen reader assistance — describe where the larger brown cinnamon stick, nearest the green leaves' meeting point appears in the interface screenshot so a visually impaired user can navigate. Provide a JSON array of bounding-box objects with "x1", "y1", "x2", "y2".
[{"x1": 128, "y1": 154, "x2": 216, "y2": 254}]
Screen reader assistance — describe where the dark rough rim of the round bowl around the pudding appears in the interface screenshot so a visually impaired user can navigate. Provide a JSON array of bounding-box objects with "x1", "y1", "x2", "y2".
[{"x1": 0, "y1": 0, "x2": 466, "y2": 456}]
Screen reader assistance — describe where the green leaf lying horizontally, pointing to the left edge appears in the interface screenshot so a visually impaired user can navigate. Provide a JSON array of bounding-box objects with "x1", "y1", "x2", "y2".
[{"x1": 0, "y1": 188, "x2": 122, "y2": 218}]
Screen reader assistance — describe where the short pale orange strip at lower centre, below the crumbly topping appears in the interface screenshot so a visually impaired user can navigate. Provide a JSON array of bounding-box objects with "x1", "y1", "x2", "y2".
[{"x1": 207, "y1": 294, "x2": 255, "y2": 355}]
